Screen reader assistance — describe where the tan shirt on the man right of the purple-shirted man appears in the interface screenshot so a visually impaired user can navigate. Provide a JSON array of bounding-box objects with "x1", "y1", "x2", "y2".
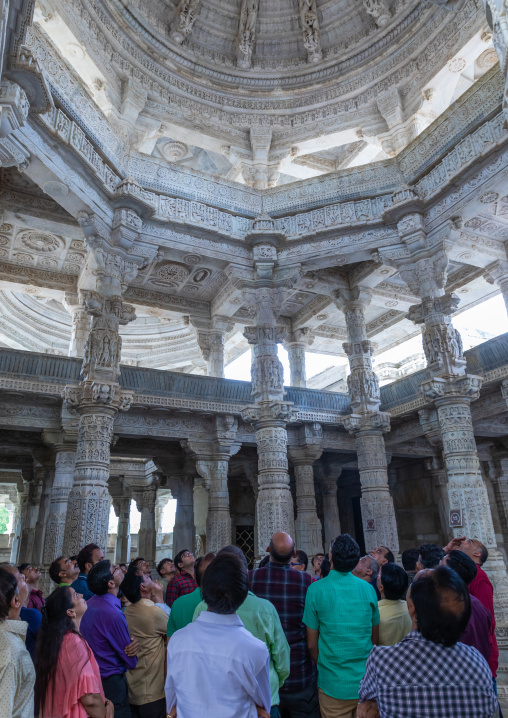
[{"x1": 124, "y1": 598, "x2": 168, "y2": 706}]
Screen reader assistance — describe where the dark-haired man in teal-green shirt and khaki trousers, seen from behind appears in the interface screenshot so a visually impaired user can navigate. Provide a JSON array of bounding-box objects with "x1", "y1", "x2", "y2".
[{"x1": 303, "y1": 534, "x2": 379, "y2": 718}]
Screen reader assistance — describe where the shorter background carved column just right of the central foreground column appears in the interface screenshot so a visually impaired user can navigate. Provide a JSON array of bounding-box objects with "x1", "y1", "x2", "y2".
[{"x1": 288, "y1": 424, "x2": 323, "y2": 556}]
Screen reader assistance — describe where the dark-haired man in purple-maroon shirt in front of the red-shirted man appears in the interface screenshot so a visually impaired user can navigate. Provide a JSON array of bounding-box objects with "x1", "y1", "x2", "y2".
[{"x1": 441, "y1": 551, "x2": 492, "y2": 663}]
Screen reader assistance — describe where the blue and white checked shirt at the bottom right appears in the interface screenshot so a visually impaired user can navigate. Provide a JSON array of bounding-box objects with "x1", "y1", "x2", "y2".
[{"x1": 360, "y1": 631, "x2": 497, "y2": 718}]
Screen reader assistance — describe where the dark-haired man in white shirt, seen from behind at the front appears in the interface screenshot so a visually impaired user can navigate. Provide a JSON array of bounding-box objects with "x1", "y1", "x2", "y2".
[{"x1": 165, "y1": 554, "x2": 271, "y2": 718}]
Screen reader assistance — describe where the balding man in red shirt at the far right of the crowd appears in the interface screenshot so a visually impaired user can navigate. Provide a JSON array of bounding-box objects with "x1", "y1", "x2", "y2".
[{"x1": 444, "y1": 536, "x2": 499, "y2": 689}]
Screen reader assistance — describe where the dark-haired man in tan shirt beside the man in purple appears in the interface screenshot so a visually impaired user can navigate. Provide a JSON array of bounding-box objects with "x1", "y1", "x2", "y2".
[{"x1": 122, "y1": 569, "x2": 168, "y2": 718}]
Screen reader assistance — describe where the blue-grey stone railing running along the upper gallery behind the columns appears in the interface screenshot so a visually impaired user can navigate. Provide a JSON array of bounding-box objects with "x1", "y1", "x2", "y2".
[{"x1": 0, "y1": 333, "x2": 508, "y2": 423}]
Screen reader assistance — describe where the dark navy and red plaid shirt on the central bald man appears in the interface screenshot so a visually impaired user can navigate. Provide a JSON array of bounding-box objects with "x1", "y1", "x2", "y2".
[{"x1": 249, "y1": 562, "x2": 316, "y2": 693}]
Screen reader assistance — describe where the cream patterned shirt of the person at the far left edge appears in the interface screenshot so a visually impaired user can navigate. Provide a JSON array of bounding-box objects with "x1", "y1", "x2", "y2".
[{"x1": 0, "y1": 619, "x2": 35, "y2": 718}]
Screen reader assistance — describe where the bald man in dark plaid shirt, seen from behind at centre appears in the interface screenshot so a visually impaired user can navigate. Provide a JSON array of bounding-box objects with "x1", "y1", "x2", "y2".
[{"x1": 249, "y1": 531, "x2": 320, "y2": 718}]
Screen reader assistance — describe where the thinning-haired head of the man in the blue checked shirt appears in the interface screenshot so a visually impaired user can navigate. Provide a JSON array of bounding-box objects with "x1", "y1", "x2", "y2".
[{"x1": 407, "y1": 566, "x2": 471, "y2": 646}]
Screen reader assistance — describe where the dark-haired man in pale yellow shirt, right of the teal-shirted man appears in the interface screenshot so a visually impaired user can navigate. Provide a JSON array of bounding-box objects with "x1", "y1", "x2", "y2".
[{"x1": 377, "y1": 563, "x2": 411, "y2": 646}]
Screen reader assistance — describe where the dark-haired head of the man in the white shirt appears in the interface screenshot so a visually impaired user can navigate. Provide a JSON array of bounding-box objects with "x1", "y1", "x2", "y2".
[{"x1": 201, "y1": 552, "x2": 249, "y2": 615}]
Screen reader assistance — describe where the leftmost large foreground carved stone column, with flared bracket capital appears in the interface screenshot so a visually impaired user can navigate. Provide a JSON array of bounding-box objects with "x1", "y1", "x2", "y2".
[{"x1": 63, "y1": 210, "x2": 145, "y2": 555}]
